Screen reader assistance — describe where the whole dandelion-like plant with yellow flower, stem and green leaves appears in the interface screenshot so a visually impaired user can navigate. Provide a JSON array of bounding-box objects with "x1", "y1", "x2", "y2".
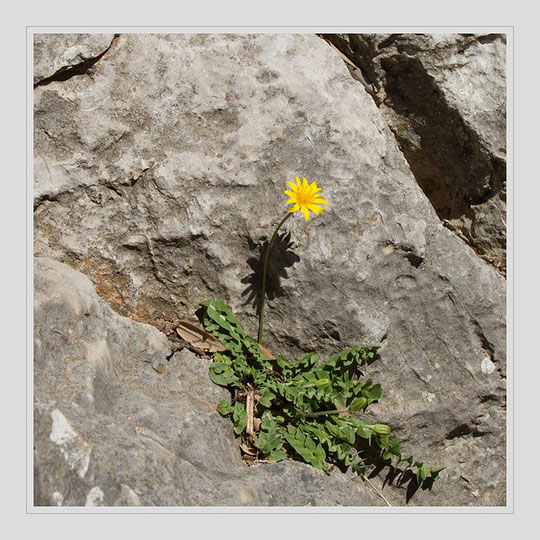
[{"x1": 199, "y1": 177, "x2": 442, "y2": 490}]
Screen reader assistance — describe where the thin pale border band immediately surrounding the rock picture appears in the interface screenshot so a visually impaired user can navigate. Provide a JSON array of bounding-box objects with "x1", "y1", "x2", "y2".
[{"x1": 26, "y1": 25, "x2": 515, "y2": 515}]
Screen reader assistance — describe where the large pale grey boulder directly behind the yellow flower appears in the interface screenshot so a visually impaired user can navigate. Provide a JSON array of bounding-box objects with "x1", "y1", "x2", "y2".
[{"x1": 34, "y1": 34, "x2": 506, "y2": 505}]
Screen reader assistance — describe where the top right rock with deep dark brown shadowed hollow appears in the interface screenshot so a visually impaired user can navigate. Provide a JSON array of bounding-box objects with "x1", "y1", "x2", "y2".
[{"x1": 325, "y1": 34, "x2": 506, "y2": 272}]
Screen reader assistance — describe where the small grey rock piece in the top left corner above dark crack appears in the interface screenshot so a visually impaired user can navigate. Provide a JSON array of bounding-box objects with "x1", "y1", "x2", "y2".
[{"x1": 34, "y1": 34, "x2": 114, "y2": 84}]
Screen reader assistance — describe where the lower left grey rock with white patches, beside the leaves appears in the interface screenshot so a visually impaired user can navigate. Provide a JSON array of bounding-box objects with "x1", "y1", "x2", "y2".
[{"x1": 34, "y1": 258, "x2": 382, "y2": 506}]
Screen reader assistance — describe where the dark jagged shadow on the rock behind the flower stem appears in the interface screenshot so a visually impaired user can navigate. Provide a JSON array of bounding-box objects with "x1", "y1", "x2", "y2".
[{"x1": 242, "y1": 232, "x2": 300, "y2": 312}]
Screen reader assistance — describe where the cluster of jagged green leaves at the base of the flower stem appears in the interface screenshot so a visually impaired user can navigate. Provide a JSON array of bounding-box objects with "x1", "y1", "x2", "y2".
[{"x1": 200, "y1": 300, "x2": 438, "y2": 482}]
